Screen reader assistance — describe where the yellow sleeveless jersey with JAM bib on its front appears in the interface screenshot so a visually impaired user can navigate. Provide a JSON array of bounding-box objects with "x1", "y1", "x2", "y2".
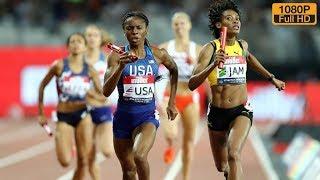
[{"x1": 208, "y1": 39, "x2": 247, "y2": 86}]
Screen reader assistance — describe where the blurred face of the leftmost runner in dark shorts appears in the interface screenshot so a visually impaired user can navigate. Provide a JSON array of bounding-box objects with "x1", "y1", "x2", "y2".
[{"x1": 68, "y1": 34, "x2": 86, "y2": 54}]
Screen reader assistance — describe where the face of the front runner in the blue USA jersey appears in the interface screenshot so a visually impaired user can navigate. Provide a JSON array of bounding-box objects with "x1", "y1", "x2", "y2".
[{"x1": 124, "y1": 17, "x2": 148, "y2": 45}]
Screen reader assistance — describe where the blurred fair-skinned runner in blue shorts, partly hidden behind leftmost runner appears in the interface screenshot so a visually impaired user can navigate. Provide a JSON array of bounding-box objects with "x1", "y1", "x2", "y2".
[{"x1": 84, "y1": 25, "x2": 114, "y2": 180}]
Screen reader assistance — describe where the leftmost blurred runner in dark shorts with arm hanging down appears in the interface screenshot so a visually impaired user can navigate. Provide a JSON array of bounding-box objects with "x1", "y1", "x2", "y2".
[{"x1": 39, "y1": 33, "x2": 101, "y2": 179}]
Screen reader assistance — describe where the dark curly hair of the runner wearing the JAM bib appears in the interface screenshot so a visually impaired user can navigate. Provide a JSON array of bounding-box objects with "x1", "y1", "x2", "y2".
[{"x1": 208, "y1": 0, "x2": 240, "y2": 38}]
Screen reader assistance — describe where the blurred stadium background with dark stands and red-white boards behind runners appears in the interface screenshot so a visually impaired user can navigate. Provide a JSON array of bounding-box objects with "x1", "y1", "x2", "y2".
[{"x1": 0, "y1": 0, "x2": 320, "y2": 179}]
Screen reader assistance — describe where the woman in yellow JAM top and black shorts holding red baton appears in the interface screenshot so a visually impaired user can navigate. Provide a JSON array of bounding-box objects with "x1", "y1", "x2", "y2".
[{"x1": 189, "y1": 0, "x2": 285, "y2": 180}]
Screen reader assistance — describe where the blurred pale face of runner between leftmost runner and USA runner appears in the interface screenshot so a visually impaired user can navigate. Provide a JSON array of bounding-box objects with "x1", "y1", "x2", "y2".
[{"x1": 85, "y1": 27, "x2": 101, "y2": 49}]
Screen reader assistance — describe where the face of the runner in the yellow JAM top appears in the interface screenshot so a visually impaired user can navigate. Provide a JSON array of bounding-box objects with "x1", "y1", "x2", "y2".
[{"x1": 221, "y1": 10, "x2": 241, "y2": 35}]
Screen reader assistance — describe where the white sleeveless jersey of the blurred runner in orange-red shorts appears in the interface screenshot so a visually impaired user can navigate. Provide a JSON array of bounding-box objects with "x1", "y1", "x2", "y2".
[{"x1": 167, "y1": 40, "x2": 197, "y2": 82}]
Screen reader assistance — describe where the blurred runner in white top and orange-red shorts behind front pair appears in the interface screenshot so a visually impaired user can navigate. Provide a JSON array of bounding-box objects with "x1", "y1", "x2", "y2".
[{"x1": 159, "y1": 12, "x2": 201, "y2": 180}]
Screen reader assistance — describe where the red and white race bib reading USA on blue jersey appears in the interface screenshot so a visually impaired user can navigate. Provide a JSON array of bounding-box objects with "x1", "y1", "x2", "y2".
[{"x1": 123, "y1": 76, "x2": 154, "y2": 103}]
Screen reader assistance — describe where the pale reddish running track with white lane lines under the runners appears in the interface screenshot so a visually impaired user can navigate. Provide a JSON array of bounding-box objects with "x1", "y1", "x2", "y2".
[{"x1": 0, "y1": 119, "x2": 267, "y2": 180}]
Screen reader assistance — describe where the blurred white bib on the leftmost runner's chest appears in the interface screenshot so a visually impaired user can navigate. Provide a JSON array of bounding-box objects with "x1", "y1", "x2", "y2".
[{"x1": 58, "y1": 71, "x2": 91, "y2": 102}]
